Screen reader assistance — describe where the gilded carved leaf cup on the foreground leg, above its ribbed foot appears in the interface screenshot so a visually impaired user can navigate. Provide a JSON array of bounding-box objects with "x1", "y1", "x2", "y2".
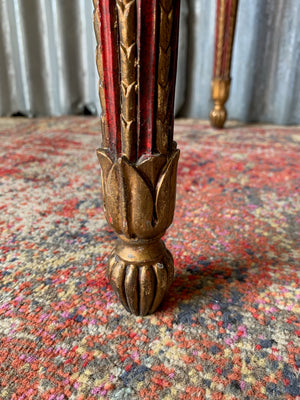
[{"x1": 97, "y1": 149, "x2": 179, "y2": 240}]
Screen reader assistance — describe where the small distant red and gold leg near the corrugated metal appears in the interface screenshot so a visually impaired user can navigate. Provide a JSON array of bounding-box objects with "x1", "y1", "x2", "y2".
[{"x1": 209, "y1": 0, "x2": 238, "y2": 128}]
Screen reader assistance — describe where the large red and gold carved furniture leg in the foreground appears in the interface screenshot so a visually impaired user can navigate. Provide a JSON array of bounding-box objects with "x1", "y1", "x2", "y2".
[{"x1": 94, "y1": 0, "x2": 180, "y2": 315}]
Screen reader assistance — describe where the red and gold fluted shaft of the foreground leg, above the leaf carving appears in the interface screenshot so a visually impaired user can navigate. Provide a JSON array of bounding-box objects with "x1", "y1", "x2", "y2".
[{"x1": 98, "y1": 0, "x2": 180, "y2": 162}]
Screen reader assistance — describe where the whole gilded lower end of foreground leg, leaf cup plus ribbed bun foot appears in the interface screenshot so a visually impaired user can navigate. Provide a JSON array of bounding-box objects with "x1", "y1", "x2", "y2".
[{"x1": 98, "y1": 148, "x2": 179, "y2": 315}]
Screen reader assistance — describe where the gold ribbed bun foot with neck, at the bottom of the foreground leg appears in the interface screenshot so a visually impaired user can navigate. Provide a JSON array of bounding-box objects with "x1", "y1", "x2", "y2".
[{"x1": 107, "y1": 240, "x2": 174, "y2": 316}]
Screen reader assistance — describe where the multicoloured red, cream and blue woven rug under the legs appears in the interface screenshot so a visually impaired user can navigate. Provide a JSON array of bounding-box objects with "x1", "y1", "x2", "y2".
[{"x1": 0, "y1": 117, "x2": 300, "y2": 400}]
